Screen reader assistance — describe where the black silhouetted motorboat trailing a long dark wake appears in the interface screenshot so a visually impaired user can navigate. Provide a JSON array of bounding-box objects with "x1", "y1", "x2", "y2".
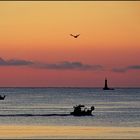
[{"x1": 70, "y1": 104, "x2": 95, "y2": 116}]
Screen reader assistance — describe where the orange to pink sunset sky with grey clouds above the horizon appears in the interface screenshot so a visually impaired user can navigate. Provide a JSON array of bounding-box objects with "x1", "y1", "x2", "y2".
[{"x1": 0, "y1": 1, "x2": 140, "y2": 87}]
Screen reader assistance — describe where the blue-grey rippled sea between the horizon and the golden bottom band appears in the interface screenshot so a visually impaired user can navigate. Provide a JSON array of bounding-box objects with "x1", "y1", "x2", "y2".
[{"x1": 0, "y1": 88, "x2": 140, "y2": 127}]
